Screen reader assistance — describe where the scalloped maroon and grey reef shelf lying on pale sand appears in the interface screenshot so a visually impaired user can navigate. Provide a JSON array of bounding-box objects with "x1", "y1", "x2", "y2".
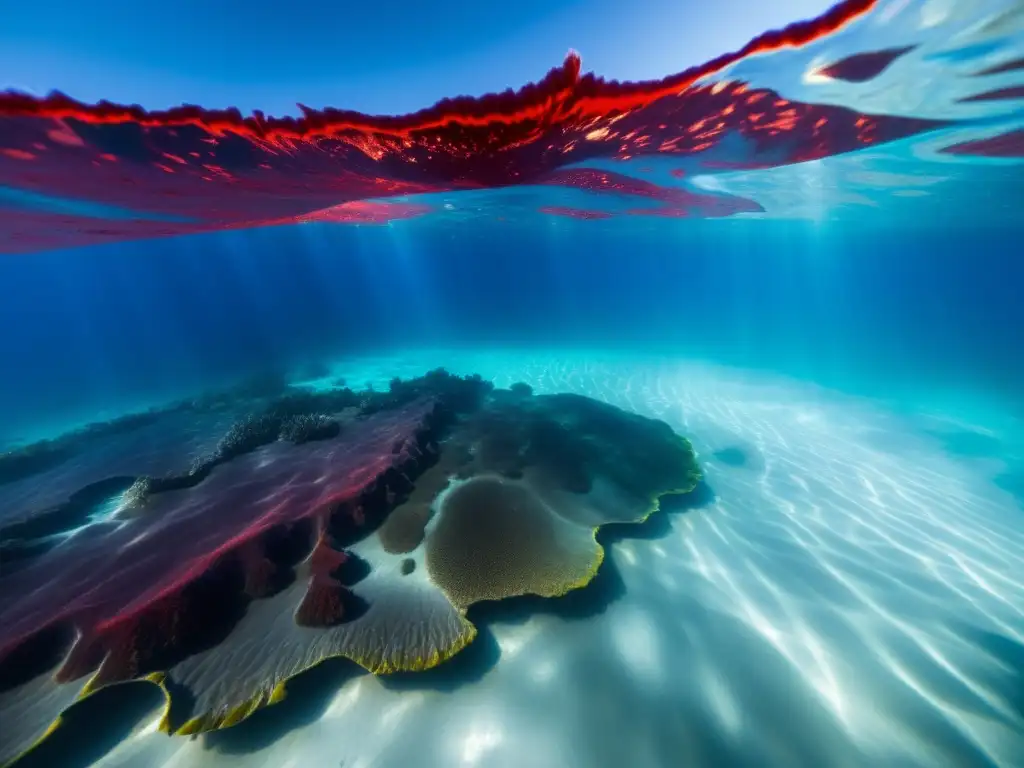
[{"x1": 0, "y1": 370, "x2": 700, "y2": 761}]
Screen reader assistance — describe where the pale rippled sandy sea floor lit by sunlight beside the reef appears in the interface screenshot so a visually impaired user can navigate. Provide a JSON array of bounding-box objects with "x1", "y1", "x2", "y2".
[{"x1": 24, "y1": 350, "x2": 1024, "y2": 768}]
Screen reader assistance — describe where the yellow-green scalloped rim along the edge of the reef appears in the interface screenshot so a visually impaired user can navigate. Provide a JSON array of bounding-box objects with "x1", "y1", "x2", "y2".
[{"x1": 3, "y1": 412, "x2": 701, "y2": 768}]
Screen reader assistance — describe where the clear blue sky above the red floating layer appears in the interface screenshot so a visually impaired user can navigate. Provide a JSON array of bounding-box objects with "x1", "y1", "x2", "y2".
[{"x1": 0, "y1": 0, "x2": 830, "y2": 115}]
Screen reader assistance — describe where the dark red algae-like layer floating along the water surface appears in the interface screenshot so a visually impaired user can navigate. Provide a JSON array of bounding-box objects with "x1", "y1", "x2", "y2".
[{"x1": 0, "y1": 0, "x2": 978, "y2": 253}]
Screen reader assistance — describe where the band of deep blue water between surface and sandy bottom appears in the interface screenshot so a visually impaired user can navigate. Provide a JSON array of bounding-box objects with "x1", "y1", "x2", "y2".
[{"x1": 0, "y1": 221, "x2": 1024, "y2": 440}]
